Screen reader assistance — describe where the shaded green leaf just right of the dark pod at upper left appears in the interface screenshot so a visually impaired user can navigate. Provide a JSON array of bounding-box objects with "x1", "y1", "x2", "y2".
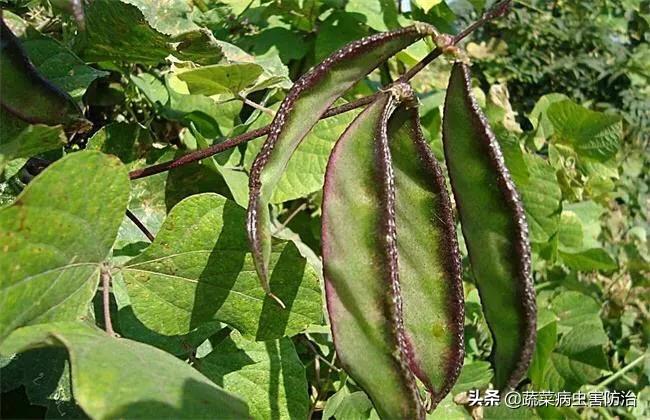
[{"x1": 22, "y1": 29, "x2": 109, "y2": 100}]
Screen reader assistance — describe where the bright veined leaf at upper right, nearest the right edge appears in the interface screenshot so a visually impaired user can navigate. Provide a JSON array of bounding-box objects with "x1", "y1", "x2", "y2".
[{"x1": 547, "y1": 100, "x2": 623, "y2": 161}]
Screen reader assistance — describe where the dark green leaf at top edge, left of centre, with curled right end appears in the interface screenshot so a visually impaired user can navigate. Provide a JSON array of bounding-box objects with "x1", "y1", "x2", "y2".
[{"x1": 79, "y1": 0, "x2": 223, "y2": 65}]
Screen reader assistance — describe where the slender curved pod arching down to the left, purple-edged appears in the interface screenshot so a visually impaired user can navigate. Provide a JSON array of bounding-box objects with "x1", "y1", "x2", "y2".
[{"x1": 247, "y1": 24, "x2": 436, "y2": 306}]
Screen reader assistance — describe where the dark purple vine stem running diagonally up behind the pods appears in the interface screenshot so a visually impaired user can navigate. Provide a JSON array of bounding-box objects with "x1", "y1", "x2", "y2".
[{"x1": 129, "y1": 0, "x2": 512, "y2": 179}]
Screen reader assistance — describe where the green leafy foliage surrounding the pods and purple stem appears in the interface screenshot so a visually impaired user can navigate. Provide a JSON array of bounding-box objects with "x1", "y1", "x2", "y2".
[{"x1": 0, "y1": 0, "x2": 650, "y2": 418}]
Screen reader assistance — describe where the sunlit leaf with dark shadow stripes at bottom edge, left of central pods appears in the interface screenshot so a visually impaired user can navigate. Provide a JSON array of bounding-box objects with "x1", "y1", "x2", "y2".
[{"x1": 198, "y1": 332, "x2": 310, "y2": 419}]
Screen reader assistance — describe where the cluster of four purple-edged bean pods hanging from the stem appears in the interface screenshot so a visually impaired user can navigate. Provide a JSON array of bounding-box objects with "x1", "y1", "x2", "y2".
[{"x1": 247, "y1": 25, "x2": 536, "y2": 418}]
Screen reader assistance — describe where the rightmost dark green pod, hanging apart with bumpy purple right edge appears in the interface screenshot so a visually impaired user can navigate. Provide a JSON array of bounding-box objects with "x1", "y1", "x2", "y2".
[{"x1": 443, "y1": 63, "x2": 536, "y2": 389}]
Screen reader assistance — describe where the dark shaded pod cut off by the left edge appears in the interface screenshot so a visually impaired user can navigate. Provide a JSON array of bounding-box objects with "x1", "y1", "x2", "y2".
[{"x1": 0, "y1": 20, "x2": 88, "y2": 127}]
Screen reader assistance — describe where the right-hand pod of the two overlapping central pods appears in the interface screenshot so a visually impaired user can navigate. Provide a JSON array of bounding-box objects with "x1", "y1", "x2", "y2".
[{"x1": 388, "y1": 97, "x2": 465, "y2": 407}]
